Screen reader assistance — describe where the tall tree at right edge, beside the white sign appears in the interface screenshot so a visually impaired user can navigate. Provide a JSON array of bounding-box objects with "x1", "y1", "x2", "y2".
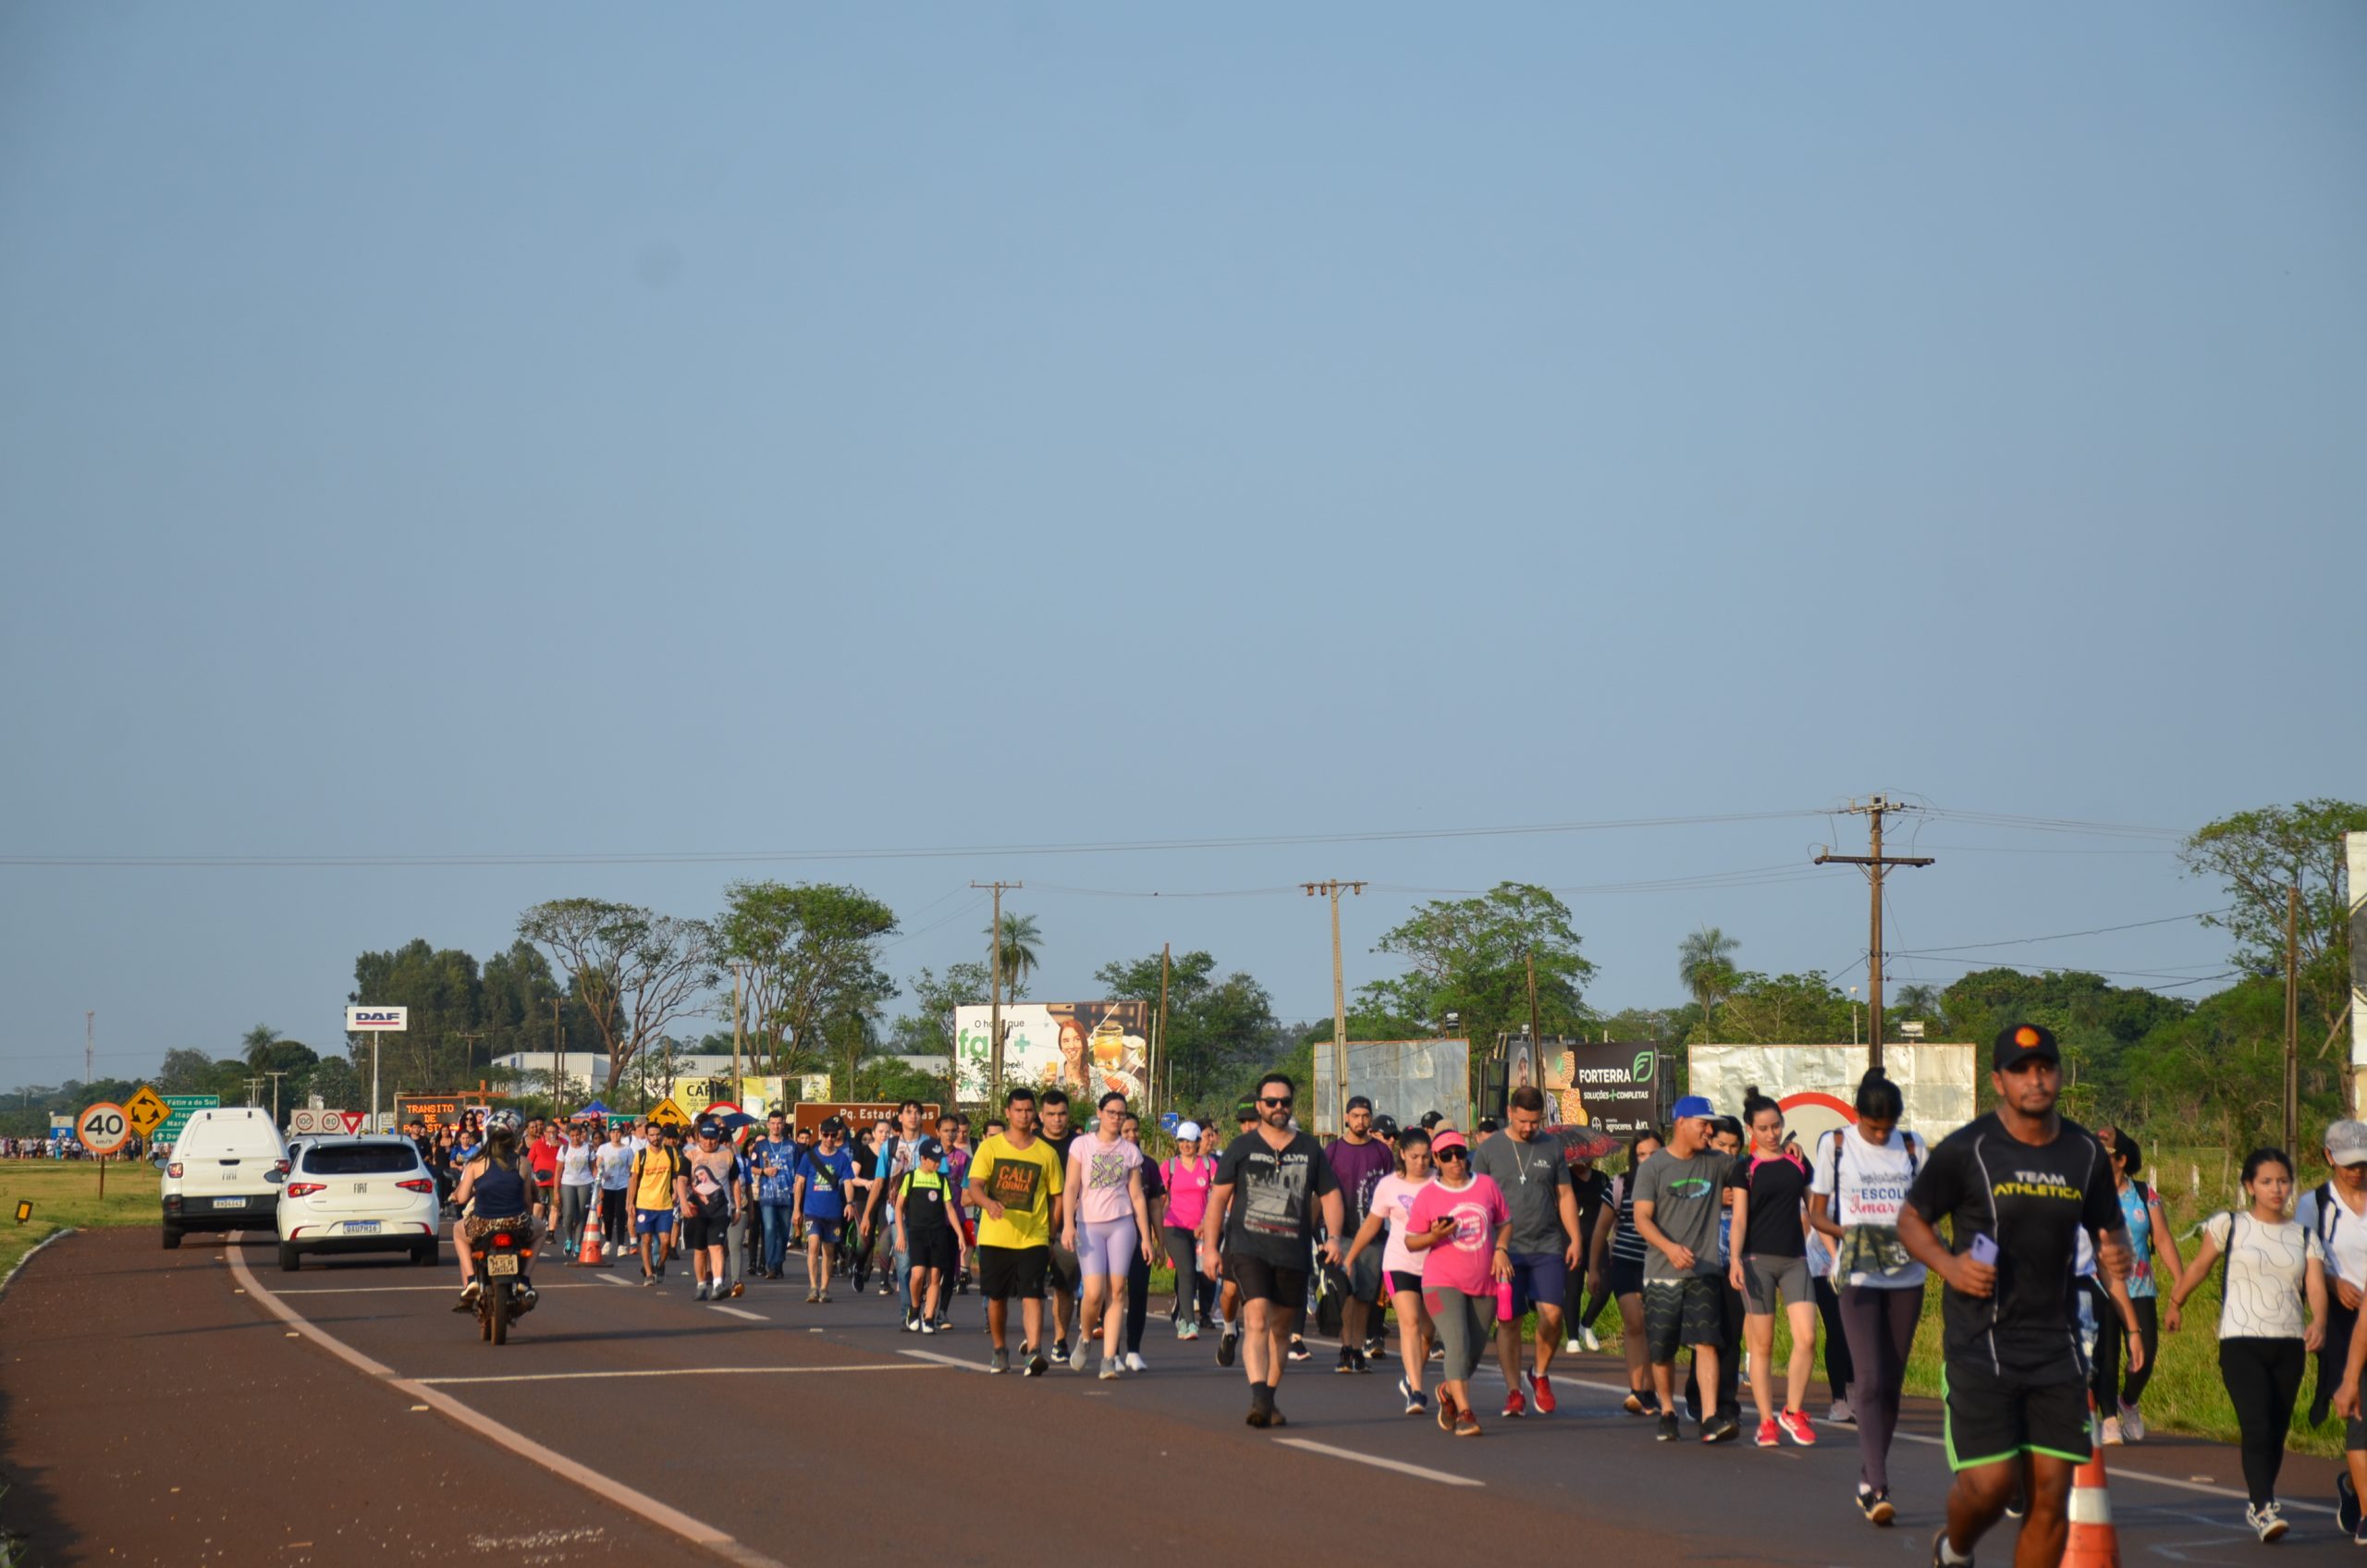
[{"x1": 2177, "y1": 801, "x2": 2367, "y2": 1059}]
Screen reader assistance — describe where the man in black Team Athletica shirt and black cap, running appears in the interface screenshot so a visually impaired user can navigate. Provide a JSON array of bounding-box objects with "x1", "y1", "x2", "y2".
[{"x1": 1898, "y1": 1023, "x2": 2130, "y2": 1568}]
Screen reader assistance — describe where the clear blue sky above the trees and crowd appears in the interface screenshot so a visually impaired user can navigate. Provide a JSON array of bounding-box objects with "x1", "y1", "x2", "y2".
[{"x1": 0, "y1": 0, "x2": 2367, "y2": 1083}]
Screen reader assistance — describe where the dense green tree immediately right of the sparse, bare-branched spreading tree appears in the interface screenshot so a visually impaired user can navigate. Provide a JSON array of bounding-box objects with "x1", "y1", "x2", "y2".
[{"x1": 715, "y1": 881, "x2": 897, "y2": 1073}]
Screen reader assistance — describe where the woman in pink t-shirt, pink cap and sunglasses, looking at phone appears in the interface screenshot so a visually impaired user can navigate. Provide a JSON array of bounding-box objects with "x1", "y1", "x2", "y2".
[{"x1": 1406, "y1": 1130, "x2": 1513, "y2": 1438}]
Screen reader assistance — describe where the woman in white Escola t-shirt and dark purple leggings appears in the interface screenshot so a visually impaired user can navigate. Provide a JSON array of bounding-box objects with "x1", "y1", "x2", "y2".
[{"x1": 1809, "y1": 1068, "x2": 1932, "y2": 1525}]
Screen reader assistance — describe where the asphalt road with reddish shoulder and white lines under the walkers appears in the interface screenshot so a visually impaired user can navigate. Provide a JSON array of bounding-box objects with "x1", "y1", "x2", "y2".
[{"x1": 0, "y1": 1231, "x2": 2355, "y2": 1568}]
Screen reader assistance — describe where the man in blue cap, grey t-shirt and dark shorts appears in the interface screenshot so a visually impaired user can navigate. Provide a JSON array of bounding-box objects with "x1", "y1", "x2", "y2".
[{"x1": 1636, "y1": 1095, "x2": 1742, "y2": 1442}]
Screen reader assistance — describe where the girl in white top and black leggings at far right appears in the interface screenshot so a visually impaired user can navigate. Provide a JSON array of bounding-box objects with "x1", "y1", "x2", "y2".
[{"x1": 2171, "y1": 1149, "x2": 2326, "y2": 1542}]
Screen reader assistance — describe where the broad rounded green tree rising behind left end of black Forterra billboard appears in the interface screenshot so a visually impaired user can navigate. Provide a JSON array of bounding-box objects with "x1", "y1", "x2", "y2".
[{"x1": 1356, "y1": 881, "x2": 1595, "y2": 1051}]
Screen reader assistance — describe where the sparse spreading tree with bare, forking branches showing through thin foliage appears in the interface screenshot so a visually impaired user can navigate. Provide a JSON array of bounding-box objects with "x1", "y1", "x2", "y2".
[{"x1": 519, "y1": 898, "x2": 719, "y2": 1095}]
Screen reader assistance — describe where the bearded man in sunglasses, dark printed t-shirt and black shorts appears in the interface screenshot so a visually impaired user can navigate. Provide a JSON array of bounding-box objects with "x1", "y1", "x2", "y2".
[{"x1": 1200, "y1": 1073, "x2": 1347, "y2": 1428}]
